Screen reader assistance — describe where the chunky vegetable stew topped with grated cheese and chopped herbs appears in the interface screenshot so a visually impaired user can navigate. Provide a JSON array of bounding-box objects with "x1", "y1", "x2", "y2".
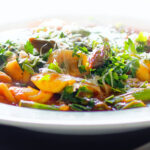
[{"x1": 0, "y1": 19, "x2": 150, "y2": 111}]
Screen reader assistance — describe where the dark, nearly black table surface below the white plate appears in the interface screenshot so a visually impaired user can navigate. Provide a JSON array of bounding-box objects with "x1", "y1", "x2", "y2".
[{"x1": 0, "y1": 125, "x2": 150, "y2": 150}]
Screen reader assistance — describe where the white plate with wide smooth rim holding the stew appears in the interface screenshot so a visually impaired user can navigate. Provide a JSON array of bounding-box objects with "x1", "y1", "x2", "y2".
[{"x1": 0, "y1": 16, "x2": 150, "y2": 135}]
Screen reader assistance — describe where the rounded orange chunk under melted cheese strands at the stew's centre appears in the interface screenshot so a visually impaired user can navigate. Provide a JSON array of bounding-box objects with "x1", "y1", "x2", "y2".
[{"x1": 48, "y1": 50, "x2": 89, "y2": 77}]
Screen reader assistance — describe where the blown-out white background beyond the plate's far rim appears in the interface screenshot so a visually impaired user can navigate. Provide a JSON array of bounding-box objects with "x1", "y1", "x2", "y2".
[{"x1": 0, "y1": 0, "x2": 150, "y2": 21}]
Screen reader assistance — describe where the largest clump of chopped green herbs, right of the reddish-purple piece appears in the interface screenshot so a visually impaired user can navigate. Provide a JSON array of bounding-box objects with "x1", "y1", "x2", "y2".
[{"x1": 91, "y1": 56, "x2": 128, "y2": 91}]
